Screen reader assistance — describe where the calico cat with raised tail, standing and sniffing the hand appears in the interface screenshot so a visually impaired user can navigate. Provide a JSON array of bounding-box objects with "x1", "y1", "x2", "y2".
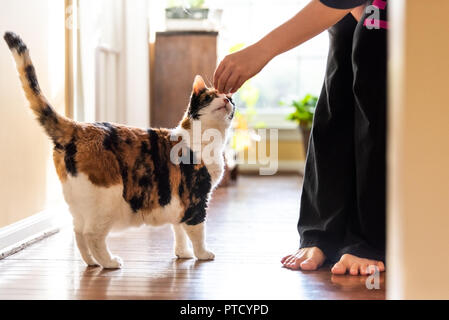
[{"x1": 4, "y1": 32, "x2": 235, "y2": 268}]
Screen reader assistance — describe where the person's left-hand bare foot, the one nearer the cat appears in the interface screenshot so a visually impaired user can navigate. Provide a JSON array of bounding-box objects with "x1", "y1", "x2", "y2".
[{"x1": 281, "y1": 247, "x2": 326, "y2": 271}]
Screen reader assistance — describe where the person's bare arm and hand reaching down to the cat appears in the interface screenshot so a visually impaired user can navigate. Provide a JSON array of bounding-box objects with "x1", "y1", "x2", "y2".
[{"x1": 214, "y1": 0, "x2": 352, "y2": 93}]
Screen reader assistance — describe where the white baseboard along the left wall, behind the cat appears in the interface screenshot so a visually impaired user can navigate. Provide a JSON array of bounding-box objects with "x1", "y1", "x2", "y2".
[{"x1": 0, "y1": 206, "x2": 69, "y2": 260}]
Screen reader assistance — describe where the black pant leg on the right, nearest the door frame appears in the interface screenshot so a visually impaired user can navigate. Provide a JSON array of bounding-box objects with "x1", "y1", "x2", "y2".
[{"x1": 340, "y1": 1, "x2": 387, "y2": 260}]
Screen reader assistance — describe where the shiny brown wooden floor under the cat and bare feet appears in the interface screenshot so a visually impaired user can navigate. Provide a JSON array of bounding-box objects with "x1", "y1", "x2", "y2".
[{"x1": 0, "y1": 176, "x2": 385, "y2": 299}]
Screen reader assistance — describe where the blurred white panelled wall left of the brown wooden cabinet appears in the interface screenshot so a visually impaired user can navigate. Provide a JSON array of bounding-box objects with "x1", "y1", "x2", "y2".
[{"x1": 75, "y1": 0, "x2": 149, "y2": 127}]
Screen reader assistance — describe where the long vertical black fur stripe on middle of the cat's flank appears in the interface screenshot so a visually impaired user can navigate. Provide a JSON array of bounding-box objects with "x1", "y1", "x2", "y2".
[{"x1": 148, "y1": 129, "x2": 171, "y2": 207}]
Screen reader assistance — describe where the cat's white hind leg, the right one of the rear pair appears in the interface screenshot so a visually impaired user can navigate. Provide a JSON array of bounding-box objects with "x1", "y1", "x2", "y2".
[{"x1": 83, "y1": 222, "x2": 123, "y2": 269}]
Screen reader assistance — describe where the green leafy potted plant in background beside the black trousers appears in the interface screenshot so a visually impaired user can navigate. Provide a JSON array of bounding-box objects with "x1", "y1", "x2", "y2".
[{"x1": 281, "y1": 94, "x2": 318, "y2": 153}]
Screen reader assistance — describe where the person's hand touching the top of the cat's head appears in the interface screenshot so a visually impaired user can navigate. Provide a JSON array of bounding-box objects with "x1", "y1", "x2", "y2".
[{"x1": 214, "y1": 45, "x2": 271, "y2": 94}]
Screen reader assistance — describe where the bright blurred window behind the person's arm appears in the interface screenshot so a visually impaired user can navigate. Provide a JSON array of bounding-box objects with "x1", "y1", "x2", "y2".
[{"x1": 215, "y1": 0, "x2": 328, "y2": 120}]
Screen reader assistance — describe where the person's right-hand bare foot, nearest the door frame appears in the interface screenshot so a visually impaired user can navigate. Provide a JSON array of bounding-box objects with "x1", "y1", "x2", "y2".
[{"x1": 331, "y1": 254, "x2": 385, "y2": 276}]
